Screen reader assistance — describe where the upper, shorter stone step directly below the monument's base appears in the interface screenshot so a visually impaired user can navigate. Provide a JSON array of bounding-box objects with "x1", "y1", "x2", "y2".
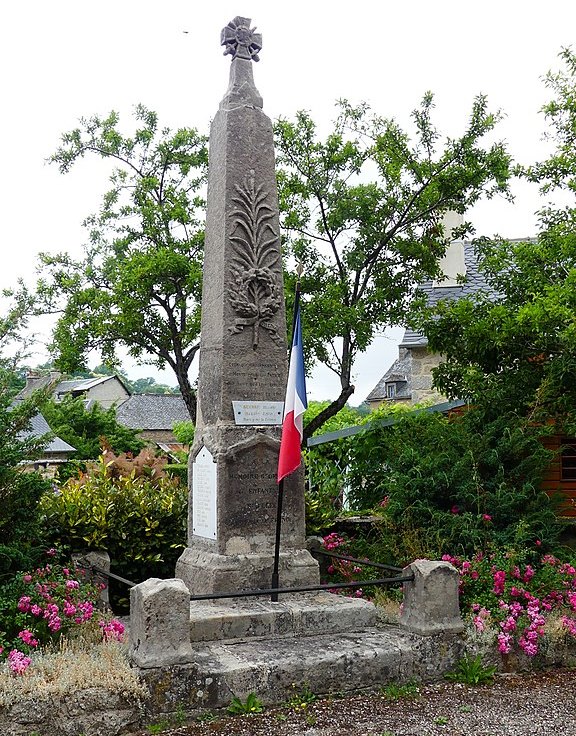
[{"x1": 190, "y1": 591, "x2": 378, "y2": 642}]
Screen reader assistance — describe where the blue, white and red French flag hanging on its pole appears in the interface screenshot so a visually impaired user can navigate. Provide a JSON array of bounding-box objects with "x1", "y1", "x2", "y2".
[{"x1": 278, "y1": 305, "x2": 308, "y2": 483}]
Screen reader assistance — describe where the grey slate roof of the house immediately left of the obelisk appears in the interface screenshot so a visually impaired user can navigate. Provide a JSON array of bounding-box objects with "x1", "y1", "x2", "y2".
[{"x1": 116, "y1": 394, "x2": 191, "y2": 430}]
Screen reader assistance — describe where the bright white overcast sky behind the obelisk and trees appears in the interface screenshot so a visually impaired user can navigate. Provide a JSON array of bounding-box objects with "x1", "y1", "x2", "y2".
[{"x1": 0, "y1": 0, "x2": 576, "y2": 404}]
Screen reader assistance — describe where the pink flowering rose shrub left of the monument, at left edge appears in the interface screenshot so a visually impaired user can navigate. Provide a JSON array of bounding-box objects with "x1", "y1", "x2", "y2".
[{"x1": 0, "y1": 550, "x2": 124, "y2": 675}]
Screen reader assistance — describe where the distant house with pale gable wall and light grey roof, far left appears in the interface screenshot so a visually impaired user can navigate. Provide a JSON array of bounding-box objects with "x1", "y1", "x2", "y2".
[{"x1": 18, "y1": 371, "x2": 130, "y2": 409}]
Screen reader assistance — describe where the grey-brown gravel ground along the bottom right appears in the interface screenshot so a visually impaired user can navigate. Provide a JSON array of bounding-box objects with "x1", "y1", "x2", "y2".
[{"x1": 138, "y1": 670, "x2": 576, "y2": 736}]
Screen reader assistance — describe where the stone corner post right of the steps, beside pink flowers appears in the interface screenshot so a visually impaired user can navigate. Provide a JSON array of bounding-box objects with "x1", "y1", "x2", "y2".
[{"x1": 400, "y1": 560, "x2": 464, "y2": 636}]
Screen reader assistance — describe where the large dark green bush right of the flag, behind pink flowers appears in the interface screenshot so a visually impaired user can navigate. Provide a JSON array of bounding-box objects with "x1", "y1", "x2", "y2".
[{"x1": 309, "y1": 408, "x2": 562, "y2": 563}]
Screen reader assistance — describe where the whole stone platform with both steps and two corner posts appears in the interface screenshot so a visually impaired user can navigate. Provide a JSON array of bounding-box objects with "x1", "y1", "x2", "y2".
[{"x1": 129, "y1": 560, "x2": 464, "y2": 712}]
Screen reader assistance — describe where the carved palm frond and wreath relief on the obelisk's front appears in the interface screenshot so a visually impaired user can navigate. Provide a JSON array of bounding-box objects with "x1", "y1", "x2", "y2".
[{"x1": 228, "y1": 171, "x2": 282, "y2": 349}]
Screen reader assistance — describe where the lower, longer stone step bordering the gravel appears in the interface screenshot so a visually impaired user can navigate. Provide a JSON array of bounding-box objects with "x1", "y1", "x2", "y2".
[{"x1": 140, "y1": 626, "x2": 463, "y2": 708}]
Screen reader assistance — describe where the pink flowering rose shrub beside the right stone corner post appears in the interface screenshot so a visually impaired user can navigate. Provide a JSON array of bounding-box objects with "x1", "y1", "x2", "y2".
[{"x1": 442, "y1": 552, "x2": 576, "y2": 657}]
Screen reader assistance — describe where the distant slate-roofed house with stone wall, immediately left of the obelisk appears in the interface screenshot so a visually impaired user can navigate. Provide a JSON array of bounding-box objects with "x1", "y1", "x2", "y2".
[{"x1": 116, "y1": 394, "x2": 191, "y2": 453}]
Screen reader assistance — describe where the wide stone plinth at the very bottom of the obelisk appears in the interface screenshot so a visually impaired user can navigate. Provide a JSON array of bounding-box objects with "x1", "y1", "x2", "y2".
[{"x1": 176, "y1": 547, "x2": 320, "y2": 595}]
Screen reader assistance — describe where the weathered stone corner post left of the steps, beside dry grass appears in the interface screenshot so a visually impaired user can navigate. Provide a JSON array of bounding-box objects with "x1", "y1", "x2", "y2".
[{"x1": 128, "y1": 578, "x2": 192, "y2": 669}]
